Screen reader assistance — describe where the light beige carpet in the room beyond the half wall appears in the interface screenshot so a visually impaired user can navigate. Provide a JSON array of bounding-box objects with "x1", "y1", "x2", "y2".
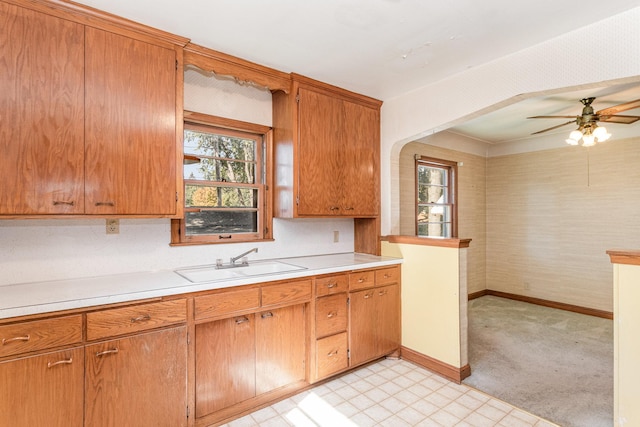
[{"x1": 463, "y1": 296, "x2": 613, "y2": 427}]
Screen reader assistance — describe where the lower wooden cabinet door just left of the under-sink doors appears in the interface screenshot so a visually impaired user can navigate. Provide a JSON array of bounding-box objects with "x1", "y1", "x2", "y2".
[{"x1": 85, "y1": 326, "x2": 187, "y2": 427}]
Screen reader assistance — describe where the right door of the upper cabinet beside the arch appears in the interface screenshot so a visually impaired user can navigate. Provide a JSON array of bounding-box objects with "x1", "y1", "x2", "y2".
[{"x1": 341, "y1": 101, "x2": 380, "y2": 216}]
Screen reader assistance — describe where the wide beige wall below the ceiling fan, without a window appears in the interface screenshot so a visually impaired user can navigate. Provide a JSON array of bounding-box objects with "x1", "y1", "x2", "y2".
[{"x1": 486, "y1": 137, "x2": 640, "y2": 311}]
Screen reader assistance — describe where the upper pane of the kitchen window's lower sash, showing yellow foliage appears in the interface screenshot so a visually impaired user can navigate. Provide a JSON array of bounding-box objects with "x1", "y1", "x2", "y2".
[{"x1": 185, "y1": 184, "x2": 258, "y2": 208}]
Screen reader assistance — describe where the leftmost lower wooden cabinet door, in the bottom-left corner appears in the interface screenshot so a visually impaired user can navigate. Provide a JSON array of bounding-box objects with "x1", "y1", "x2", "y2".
[{"x1": 0, "y1": 348, "x2": 84, "y2": 427}]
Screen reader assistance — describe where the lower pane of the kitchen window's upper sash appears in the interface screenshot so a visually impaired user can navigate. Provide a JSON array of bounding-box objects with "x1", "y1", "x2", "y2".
[{"x1": 184, "y1": 157, "x2": 256, "y2": 184}]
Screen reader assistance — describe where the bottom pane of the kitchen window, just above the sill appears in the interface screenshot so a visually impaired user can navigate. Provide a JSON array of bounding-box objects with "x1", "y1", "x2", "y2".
[{"x1": 185, "y1": 210, "x2": 258, "y2": 235}]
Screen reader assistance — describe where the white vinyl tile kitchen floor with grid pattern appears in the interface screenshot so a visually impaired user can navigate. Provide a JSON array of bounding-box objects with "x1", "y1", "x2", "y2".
[{"x1": 219, "y1": 359, "x2": 556, "y2": 427}]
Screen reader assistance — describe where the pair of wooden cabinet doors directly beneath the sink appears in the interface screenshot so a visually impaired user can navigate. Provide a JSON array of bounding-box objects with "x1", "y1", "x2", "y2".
[{"x1": 195, "y1": 304, "x2": 307, "y2": 418}]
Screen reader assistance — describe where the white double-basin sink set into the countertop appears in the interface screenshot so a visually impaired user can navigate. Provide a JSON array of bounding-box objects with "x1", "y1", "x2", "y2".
[{"x1": 174, "y1": 261, "x2": 306, "y2": 283}]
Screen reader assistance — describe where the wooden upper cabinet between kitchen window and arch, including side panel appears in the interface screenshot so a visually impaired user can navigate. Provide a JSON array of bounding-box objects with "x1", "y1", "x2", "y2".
[{"x1": 273, "y1": 74, "x2": 381, "y2": 218}]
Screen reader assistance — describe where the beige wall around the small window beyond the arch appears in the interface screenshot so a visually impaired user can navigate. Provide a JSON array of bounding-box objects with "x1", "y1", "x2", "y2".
[{"x1": 400, "y1": 133, "x2": 487, "y2": 293}]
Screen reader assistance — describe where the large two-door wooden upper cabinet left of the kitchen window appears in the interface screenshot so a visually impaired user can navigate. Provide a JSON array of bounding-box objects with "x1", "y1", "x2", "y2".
[{"x1": 0, "y1": 2, "x2": 182, "y2": 217}]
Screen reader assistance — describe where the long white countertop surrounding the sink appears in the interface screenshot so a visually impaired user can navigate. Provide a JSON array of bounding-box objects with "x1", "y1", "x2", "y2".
[{"x1": 0, "y1": 253, "x2": 402, "y2": 319}]
